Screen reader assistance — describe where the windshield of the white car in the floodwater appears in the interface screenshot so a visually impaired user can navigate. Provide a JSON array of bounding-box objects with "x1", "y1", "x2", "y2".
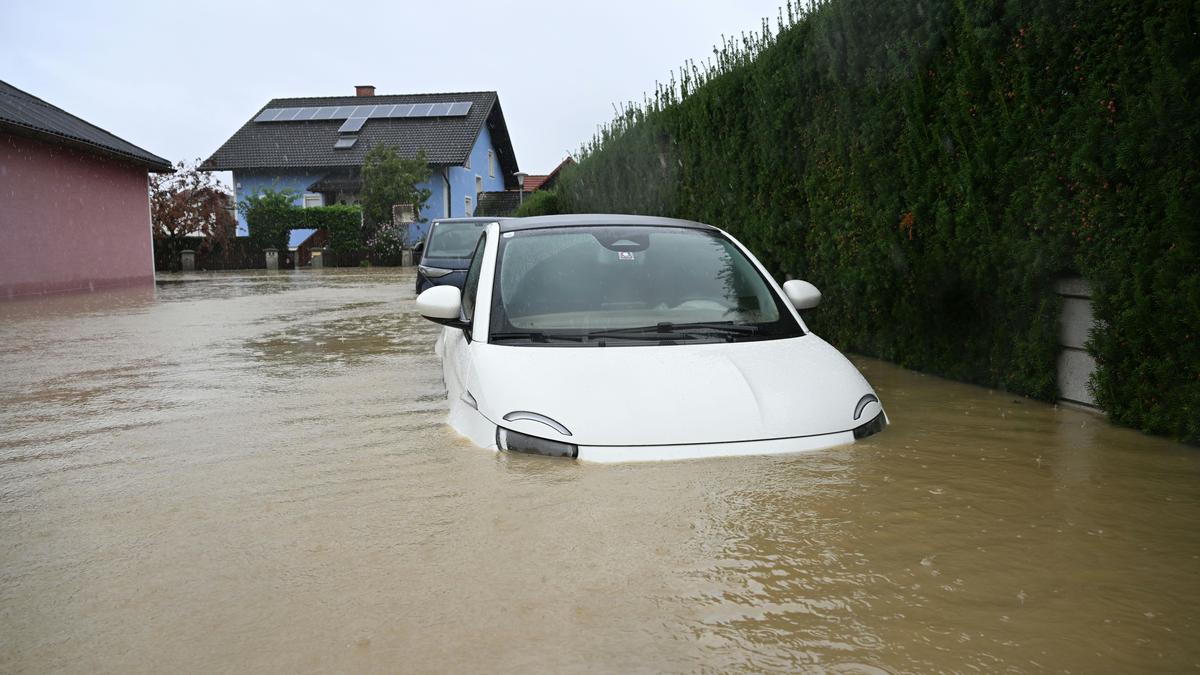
[{"x1": 488, "y1": 226, "x2": 803, "y2": 346}]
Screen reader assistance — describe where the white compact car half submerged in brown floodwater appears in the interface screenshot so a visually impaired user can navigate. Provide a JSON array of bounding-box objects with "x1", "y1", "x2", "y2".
[{"x1": 416, "y1": 215, "x2": 888, "y2": 462}]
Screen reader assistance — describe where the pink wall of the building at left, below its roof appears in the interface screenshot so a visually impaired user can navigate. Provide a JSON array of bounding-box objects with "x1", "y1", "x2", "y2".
[{"x1": 0, "y1": 133, "x2": 154, "y2": 299}]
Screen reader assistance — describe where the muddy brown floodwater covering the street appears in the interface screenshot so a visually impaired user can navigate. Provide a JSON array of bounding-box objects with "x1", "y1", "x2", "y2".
[{"x1": 0, "y1": 270, "x2": 1200, "y2": 673}]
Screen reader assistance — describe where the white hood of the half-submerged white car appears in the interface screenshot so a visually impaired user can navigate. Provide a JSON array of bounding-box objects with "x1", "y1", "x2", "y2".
[{"x1": 467, "y1": 334, "x2": 882, "y2": 446}]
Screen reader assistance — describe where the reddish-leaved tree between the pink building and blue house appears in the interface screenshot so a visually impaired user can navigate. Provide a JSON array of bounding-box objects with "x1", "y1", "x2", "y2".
[{"x1": 150, "y1": 160, "x2": 238, "y2": 269}]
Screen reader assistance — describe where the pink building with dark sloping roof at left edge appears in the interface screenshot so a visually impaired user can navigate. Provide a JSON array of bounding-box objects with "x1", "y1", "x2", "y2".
[{"x1": 0, "y1": 82, "x2": 173, "y2": 299}]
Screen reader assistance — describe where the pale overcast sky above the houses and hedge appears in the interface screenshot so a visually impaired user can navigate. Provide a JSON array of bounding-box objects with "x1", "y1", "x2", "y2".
[{"x1": 0, "y1": 0, "x2": 780, "y2": 182}]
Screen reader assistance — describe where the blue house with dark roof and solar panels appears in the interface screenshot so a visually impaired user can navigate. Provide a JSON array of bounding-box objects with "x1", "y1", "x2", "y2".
[{"x1": 200, "y1": 85, "x2": 517, "y2": 247}]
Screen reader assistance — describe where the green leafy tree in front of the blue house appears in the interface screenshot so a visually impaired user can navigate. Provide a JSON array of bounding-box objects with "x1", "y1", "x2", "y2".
[{"x1": 359, "y1": 145, "x2": 432, "y2": 252}]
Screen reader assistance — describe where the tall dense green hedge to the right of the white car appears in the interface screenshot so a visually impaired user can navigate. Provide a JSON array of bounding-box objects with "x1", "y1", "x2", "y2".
[{"x1": 558, "y1": 0, "x2": 1200, "y2": 443}]
